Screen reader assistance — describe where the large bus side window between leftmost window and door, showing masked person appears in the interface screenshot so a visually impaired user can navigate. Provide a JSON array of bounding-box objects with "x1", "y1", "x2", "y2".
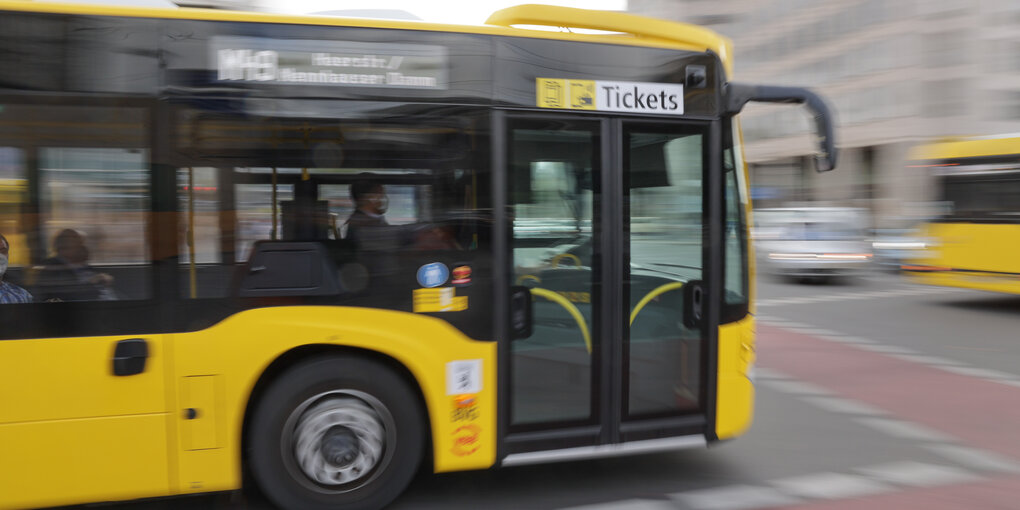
[{"x1": 174, "y1": 102, "x2": 490, "y2": 310}]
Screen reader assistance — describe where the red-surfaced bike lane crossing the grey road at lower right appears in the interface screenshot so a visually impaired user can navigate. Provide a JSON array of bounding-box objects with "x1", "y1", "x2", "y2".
[{"x1": 758, "y1": 324, "x2": 1020, "y2": 510}]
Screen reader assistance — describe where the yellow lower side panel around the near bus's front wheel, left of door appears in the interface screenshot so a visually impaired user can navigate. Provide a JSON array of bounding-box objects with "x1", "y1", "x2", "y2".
[{"x1": 0, "y1": 306, "x2": 496, "y2": 508}]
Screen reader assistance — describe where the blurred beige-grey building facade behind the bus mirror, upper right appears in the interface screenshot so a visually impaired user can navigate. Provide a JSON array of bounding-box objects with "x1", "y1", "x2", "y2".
[{"x1": 628, "y1": 0, "x2": 1020, "y2": 226}]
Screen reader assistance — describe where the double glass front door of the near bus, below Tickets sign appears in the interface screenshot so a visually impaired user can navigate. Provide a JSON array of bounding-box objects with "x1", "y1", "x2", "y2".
[{"x1": 501, "y1": 115, "x2": 705, "y2": 463}]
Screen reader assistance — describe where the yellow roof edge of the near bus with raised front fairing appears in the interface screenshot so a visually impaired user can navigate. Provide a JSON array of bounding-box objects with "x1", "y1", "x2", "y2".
[{"x1": 0, "y1": 0, "x2": 732, "y2": 68}]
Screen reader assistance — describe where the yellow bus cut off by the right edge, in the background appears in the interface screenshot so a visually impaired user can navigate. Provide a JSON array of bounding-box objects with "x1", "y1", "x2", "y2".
[{"x1": 904, "y1": 135, "x2": 1020, "y2": 294}]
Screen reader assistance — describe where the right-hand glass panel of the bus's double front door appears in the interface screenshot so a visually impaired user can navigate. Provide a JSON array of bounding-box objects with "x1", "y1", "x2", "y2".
[{"x1": 624, "y1": 128, "x2": 704, "y2": 417}]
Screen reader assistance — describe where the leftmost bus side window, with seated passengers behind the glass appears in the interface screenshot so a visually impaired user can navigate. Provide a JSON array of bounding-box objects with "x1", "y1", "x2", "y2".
[{"x1": 0, "y1": 100, "x2": 152, "y2": 302}]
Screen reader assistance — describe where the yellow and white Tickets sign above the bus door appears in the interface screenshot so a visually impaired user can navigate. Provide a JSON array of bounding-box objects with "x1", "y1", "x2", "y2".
[{"x1": 534, "y1": 78, "x2": 683, "y2": 115}]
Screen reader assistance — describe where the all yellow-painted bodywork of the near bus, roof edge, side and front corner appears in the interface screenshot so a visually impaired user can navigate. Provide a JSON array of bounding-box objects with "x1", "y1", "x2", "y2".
[{"x1": 0, "y1": 1, "x2": 767, "y2": 509}]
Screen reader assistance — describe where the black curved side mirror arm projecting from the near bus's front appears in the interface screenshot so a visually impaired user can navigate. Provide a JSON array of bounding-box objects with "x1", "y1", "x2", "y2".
[{"x1": 725, "y1": 84, "x2": 836, "y2": 171}]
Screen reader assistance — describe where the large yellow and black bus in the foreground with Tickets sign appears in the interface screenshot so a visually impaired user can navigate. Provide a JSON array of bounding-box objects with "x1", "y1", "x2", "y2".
[{"x1": 0, "y1": 1, "x2": 835, "y2": 510}]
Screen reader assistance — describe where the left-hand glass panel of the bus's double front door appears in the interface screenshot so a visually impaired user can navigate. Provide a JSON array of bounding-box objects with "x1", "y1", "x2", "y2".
[{"x1": 509, "y1": 122, "x2": 599, "y2": 425}]
